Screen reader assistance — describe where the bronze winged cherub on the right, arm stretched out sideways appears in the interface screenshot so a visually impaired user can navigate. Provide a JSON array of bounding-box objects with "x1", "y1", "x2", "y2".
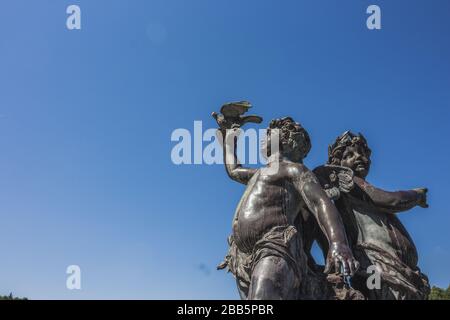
[{"x1": 314, "y1": 131, "x2": 430, "y2": 300}]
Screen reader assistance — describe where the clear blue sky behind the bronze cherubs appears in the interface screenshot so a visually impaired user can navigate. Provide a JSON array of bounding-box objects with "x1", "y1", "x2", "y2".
[{"x1": 0, "y1": 0, "x2": 450, "y2": 299}]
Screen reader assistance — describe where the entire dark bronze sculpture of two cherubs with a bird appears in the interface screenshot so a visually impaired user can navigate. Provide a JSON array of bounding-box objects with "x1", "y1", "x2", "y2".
[{"x1": 212, "y1": 101, "x2": 429, "y2": 300}]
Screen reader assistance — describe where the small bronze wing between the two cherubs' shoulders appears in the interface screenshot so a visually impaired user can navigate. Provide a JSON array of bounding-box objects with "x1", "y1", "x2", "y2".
[{"x1": 313, "y1": 165, "x2": 354, "y2": 193}]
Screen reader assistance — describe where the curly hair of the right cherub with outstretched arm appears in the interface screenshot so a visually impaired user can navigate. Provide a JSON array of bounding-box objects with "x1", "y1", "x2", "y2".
[{"x1": 327, "y1": 131, "x2": 372, "y2": 165}]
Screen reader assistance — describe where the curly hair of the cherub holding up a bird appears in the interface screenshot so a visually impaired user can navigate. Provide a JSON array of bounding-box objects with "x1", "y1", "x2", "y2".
[{"x1": 265, "y1": 117, "x2": 311, "y2": 159}]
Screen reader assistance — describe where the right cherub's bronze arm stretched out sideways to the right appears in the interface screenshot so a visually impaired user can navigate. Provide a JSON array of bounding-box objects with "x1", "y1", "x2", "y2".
[{"x1": 354, "y1": 177, "x2": 428, "y2": 213}]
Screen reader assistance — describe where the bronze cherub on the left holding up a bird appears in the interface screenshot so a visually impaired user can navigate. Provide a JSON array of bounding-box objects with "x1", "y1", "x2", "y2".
[{"x1": 213, "y1": 101, "x2": 358, "y2": 300}]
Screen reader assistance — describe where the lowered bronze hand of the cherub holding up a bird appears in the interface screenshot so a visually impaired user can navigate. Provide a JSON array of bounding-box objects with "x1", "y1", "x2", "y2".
[{"x1": 325, "y1": 242, "x2": 359, "y2": 276}]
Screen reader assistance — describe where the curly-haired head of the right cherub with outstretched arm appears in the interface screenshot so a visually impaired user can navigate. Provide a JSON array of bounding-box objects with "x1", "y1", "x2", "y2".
[{"x1": 328, "y1": 131, "x2": 372, "y2": 179}]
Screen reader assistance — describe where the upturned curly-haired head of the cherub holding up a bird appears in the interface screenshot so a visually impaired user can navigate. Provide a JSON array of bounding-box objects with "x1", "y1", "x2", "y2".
[{"x1": 264, "y1": 117, "x2": 311, "y2": 162}]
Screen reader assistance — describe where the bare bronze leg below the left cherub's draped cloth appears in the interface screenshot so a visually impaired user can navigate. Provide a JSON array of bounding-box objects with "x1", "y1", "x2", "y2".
[{"x1": 248, "y1": 256, "x2": 299, "y2": 300}]
